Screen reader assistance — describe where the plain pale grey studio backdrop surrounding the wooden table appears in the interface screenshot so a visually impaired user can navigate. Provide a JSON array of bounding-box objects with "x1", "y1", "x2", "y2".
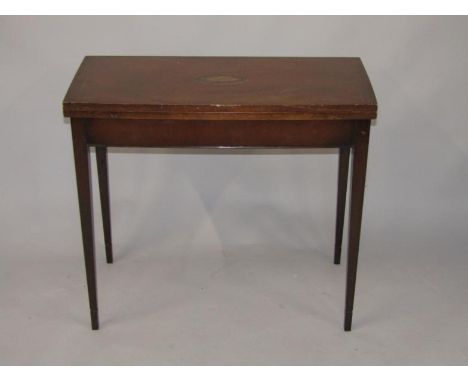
[{"x1": 0, "y1": 17, "x2": 468, "y2": 364}]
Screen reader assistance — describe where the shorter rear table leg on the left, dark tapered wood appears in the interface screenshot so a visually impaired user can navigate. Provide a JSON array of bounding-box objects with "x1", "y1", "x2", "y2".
[{"x1": 96, "y1": 146, "x2": 113, "y2": 264}]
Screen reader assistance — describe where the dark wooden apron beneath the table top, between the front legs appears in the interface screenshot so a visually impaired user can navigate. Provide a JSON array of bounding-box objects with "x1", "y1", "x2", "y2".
[{"x1": 81, "y1": 118, "x2": 356, "y2": 147}]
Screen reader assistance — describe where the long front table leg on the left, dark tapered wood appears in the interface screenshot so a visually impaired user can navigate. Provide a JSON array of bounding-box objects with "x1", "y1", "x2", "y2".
[{"x1": 71, "y1": 119, "x2": 99, "y2": 330}]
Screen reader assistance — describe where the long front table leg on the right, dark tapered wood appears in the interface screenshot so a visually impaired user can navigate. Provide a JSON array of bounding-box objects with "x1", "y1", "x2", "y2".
[{"x1": 344, "y1": 122, "x2": 369, "y2": 331}]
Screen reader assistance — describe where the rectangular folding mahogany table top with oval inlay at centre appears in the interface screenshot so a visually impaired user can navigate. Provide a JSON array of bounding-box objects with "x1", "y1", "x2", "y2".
[{"x1": 63, "y1": 56, "x2": 377, "y2": 120}]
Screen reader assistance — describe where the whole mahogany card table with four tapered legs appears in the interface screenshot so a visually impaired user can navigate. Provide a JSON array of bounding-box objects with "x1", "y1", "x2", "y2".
[{"x1": 63, "y1": 56, "x2": 377, "y2": 331}]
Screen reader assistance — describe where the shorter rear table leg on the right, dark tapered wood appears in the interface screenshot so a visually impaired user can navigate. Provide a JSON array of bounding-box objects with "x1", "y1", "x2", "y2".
[{"x1": 334, "y1": 147, "x2": 350, "y2": 264}]
